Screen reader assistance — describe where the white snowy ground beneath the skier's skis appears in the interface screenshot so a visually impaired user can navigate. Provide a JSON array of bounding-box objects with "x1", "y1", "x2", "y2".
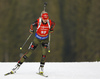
[{"x1": 0, "y1": 62, "x2": 100, "y2": 79}]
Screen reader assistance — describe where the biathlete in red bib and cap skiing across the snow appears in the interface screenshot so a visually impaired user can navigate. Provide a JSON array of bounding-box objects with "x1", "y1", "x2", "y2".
[{"x1": 11, "y1": 11, "x2": 55, "y2": 74}]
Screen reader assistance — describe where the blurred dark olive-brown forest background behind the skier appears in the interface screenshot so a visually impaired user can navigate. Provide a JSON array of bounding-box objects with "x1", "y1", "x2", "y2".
[{"x1": 0, "y1": 0, "x2": 100, "y2": 62}]
